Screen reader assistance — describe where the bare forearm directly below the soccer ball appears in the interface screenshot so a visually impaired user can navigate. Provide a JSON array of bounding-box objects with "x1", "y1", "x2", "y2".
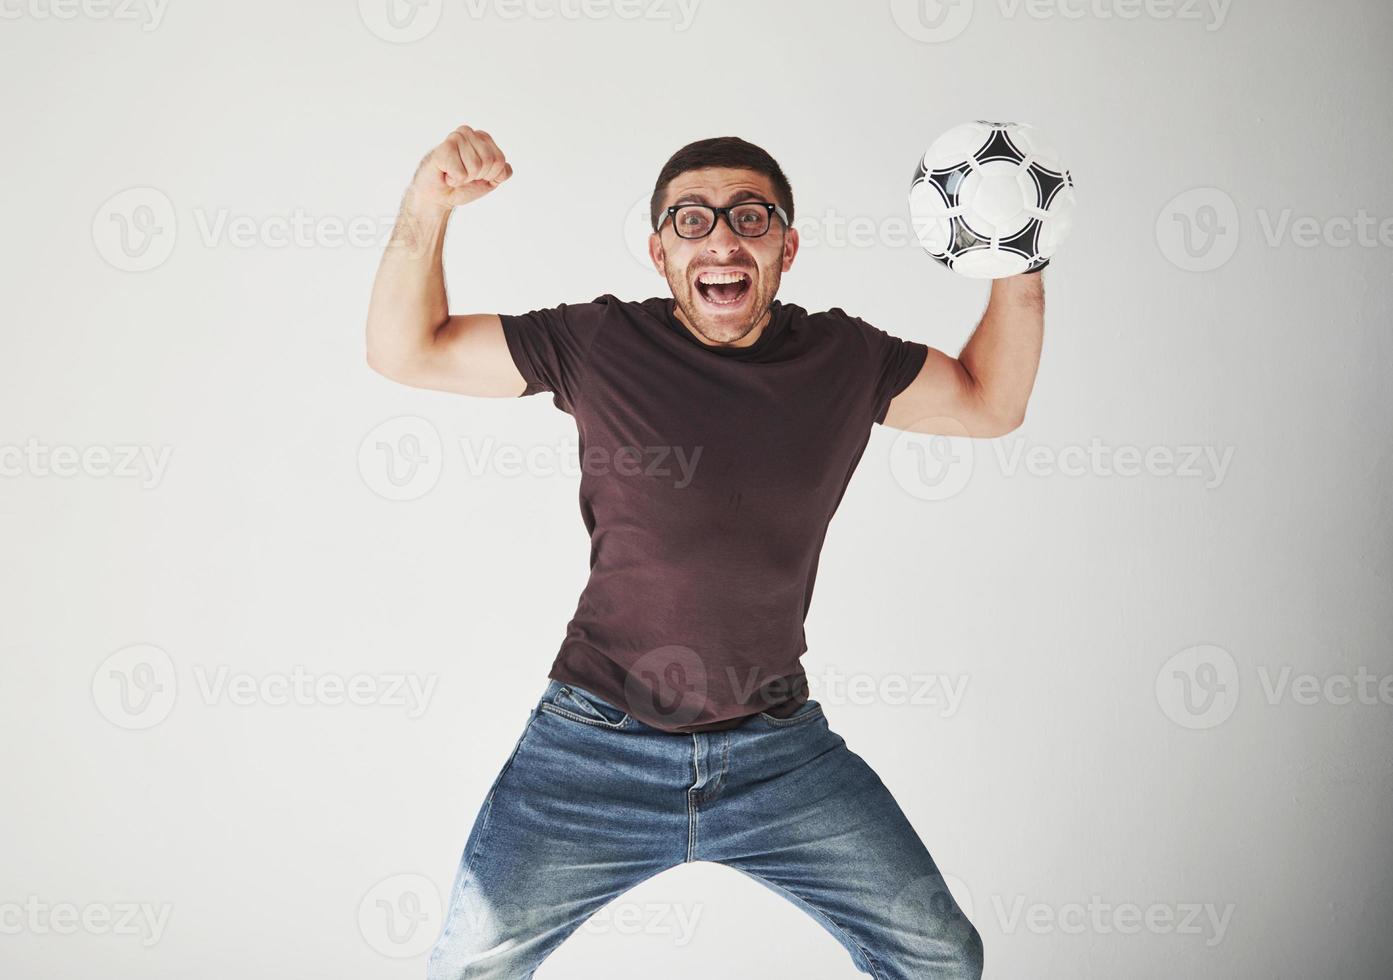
[{"x1": 958, "y1": 273, "x2": 1045, "y2": 427}]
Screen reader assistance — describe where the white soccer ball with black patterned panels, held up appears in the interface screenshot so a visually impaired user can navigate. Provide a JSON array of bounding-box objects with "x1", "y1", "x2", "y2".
[{"x1": 910, "y1": 120, "x2": 1074, "y2": 278}]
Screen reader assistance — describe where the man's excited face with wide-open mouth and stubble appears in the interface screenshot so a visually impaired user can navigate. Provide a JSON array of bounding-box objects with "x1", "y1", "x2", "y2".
[{"x1": 648, "y1": 167, "x2": 798, "y2": 347}]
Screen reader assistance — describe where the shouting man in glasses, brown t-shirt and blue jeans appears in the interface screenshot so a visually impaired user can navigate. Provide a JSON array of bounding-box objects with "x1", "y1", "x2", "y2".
[{"x1": 368, "y1": 127, "x2": 1043, "y2": 980}]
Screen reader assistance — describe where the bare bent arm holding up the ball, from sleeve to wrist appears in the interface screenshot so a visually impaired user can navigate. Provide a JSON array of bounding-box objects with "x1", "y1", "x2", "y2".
[{"x1": 885, "y1": 273, "x2": 1045, "y2": 438}]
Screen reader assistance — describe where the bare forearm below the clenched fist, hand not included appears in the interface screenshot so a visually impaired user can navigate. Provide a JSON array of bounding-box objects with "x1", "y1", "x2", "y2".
[{"x1": 368, "y1": 191, "x2": 450, "y2": 366}]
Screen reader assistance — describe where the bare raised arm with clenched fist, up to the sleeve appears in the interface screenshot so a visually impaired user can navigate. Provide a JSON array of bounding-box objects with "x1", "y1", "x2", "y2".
[{"x1": 368, "y1": 125, "x2": 525, "y2": 398}]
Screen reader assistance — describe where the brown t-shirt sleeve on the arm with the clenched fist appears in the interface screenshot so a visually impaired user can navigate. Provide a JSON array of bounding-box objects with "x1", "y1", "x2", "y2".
[{"x1": 499, "y1": 301, "x2": 602, "y2": 415}]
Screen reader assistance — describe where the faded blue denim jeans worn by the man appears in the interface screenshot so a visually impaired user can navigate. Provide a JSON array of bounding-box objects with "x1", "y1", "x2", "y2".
[{"x1": 428, "y1": 678, "x2": 982, "y2": 980}]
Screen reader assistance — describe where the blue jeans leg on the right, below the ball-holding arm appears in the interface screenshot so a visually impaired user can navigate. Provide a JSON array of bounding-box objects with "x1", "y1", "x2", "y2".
[{"x1": 702, "y1": 718, "x2": 982, "y2": 980}]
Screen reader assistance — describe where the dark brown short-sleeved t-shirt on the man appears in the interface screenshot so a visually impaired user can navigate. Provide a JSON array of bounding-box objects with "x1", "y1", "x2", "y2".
[{"x1": 501, "y1": 294, "x2": 928, "y2": 732}]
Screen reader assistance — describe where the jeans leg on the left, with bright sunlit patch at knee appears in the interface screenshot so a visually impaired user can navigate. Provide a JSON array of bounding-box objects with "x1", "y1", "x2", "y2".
[{"x1": 428, "y1": 685, "x2": 685, "y2": 980}]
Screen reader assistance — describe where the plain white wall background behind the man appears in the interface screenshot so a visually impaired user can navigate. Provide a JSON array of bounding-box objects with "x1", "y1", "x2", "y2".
[{"x1": 0, "y1": 0, "x2": 1393, "y2": 980}]
